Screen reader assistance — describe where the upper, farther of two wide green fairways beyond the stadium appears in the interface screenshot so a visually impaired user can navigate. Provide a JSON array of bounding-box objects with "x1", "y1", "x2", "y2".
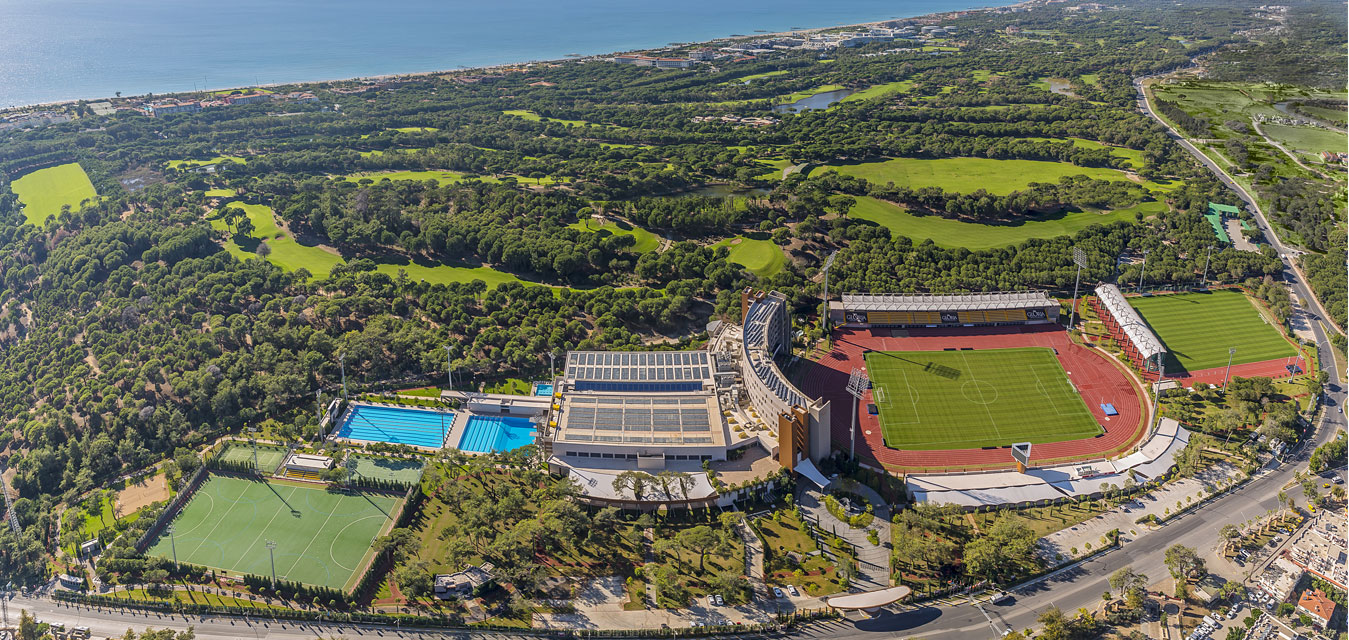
[{"x1": 815, "y1": 158, "x2": 1147, "y2": 196}]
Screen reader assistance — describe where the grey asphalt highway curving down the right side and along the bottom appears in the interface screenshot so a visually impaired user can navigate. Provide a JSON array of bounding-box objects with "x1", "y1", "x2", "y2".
[{"x1": 8, "y1": 72, "x2": 1345, "y2": 640}]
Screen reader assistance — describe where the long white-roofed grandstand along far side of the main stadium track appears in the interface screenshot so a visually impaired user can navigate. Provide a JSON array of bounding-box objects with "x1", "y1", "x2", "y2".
[{"x1": 830, "y1": 292, "x2": 1059, "y2": 328}]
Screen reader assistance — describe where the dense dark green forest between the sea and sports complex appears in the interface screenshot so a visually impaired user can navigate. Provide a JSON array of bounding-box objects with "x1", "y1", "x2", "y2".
[{"x1": 0, "y1": 1, "x2": 1344, "y2": 583}]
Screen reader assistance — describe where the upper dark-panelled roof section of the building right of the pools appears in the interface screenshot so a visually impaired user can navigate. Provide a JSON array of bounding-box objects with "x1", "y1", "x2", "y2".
[{"x1": 565, "y1": 351, "x2": 712, "y2": 386}]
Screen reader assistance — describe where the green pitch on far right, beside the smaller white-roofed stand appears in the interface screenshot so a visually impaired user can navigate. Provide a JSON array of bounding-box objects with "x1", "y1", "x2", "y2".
[{"x1": 1129, "y1": 289, "x2": 1296, "y2": 373}]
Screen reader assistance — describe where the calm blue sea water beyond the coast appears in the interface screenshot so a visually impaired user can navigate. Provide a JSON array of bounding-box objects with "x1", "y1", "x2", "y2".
[{"x1": 0, "y1": 0, "x2": 1006, "y2": 107}]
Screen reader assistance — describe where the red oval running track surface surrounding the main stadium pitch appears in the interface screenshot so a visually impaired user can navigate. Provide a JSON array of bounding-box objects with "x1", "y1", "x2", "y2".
[{"x1": 799, "y1": 324, "x2": 1149, "y2": 473}]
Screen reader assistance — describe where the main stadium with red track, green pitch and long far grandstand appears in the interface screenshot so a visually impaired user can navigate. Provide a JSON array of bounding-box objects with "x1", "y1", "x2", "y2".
[{"x1": 801, "y1": 292, "x2": 1147, "y2": 474}]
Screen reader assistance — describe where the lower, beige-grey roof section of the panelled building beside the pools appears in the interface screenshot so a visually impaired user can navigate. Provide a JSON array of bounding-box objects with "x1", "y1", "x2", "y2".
[{"x1": 561, "y1": 396, "x2": 712, "y2": 444}]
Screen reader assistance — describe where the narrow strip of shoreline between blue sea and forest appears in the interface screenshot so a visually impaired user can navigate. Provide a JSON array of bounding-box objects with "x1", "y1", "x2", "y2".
[{"x1": 0, "y1": 0, "x2": 1025, "y2": 116}]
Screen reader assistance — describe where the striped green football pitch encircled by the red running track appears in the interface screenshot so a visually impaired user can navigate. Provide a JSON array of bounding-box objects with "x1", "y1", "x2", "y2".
[{"x1": 866, "y1": 347, "x2": 1101, "y2": 450}]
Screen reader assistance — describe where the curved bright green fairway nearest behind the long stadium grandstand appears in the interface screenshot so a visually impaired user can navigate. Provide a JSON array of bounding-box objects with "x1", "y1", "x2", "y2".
[{"x1": 849, "y1": 197, "x2": 1143, "y2": 250}]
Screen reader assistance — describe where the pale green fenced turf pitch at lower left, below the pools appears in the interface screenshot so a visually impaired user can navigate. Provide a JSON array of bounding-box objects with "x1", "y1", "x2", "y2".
[{"x1": 147, "y1": 475, "x2": 398, "y2": 589}]
